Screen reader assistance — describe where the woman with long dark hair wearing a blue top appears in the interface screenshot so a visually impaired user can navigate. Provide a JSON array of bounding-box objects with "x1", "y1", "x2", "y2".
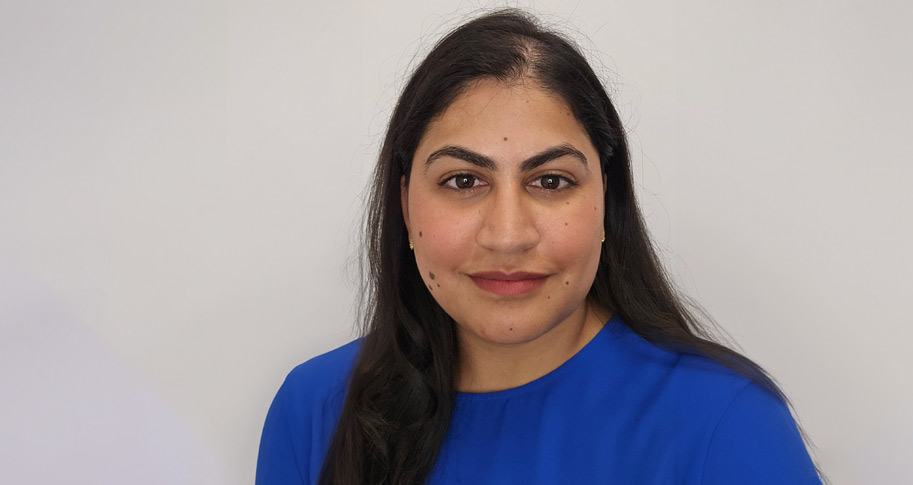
[{"x1": 257, "y1": 11, "x2": 819, "y2": 484}]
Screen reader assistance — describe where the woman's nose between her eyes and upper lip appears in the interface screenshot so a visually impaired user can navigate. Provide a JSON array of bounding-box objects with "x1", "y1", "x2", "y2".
[{"x1": 476, "y1": 186, "x2": 540, "y2": 253}]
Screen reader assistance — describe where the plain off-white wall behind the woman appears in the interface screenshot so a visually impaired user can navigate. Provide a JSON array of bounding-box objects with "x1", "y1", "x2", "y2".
[{"x1": 0, "y1": 0, "x2": 913, "y2": 484}]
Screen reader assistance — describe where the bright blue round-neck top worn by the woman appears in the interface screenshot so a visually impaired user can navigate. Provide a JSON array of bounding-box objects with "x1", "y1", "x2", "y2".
[{"x1": 257, "y1": 317, "x2": 821, "y2": 485}]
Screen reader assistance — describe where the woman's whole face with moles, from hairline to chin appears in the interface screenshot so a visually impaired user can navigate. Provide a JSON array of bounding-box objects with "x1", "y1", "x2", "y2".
[{"x1": 402, "y1": 80, "x2": 604, "y2": 350}]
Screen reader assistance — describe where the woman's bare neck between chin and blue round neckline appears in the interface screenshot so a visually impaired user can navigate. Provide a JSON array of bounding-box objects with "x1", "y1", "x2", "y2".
[{"x1": 456, "y1": 304, "x2": 609, "y2": 393}]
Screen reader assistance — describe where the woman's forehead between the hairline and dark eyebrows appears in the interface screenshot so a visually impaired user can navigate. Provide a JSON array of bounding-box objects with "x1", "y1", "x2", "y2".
[{"x1": 413, "y1": 80, "x2": 598, "y2": 167}]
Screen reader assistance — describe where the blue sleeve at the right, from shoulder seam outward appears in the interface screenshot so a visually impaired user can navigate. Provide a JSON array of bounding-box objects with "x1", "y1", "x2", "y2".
[{"x1": 702, "y1": 384, "x2": 821, "y2": 485}]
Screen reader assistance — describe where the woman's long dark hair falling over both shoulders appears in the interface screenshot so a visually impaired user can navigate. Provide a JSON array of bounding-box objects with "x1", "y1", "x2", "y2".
[{"x1": 321, "y1": 10, "x2": 785, "y2": 485}]
